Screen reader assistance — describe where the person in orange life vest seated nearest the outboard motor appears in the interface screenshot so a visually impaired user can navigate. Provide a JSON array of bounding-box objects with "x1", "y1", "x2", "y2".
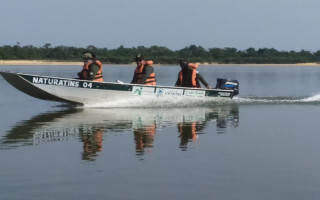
[{"x1": 175, "y1": 59, "x2": 212, "y2": 89}]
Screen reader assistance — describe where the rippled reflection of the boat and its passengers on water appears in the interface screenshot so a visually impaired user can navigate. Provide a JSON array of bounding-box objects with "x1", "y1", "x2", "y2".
[{"x1": 0, "y1": 105, "x2": 239, "y2": 160}]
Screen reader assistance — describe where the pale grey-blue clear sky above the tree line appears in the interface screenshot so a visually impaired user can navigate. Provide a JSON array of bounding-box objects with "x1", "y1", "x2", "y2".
[{"x1": 0, "y1": 0, "x2": 320, "y2": 52}]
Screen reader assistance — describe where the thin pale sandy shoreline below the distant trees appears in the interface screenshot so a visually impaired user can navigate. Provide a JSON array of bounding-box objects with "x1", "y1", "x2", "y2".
[{"x1": 0, "y1": 60, "x2": 320, "y2": 67}]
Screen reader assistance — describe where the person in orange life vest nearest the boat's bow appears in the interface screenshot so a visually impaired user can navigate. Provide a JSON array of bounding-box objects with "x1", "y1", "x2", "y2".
[{"x1": 78, "y1": 52, "x2": 103, "y2": 82}]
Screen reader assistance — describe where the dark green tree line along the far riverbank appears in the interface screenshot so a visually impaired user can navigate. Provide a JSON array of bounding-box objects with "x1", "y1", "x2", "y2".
[{"x1": 0, "y1": 43, "x2": 320, "y2": 64}]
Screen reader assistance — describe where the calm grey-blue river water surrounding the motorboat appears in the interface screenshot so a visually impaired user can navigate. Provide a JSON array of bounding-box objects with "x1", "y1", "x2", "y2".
[{"x1": 0, "y1": 65, "x2": 320, "y2": 200}]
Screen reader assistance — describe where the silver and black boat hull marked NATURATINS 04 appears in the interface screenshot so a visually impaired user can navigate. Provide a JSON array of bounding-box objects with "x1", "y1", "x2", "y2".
[{"x1": 0, "y1": 72, "x2": 234, "y2": 105}]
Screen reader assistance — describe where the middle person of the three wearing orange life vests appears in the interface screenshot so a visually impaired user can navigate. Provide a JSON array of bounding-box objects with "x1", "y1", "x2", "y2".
[{"x1": 131, "y1": 54, "x2": 157, "y2": 85}]
